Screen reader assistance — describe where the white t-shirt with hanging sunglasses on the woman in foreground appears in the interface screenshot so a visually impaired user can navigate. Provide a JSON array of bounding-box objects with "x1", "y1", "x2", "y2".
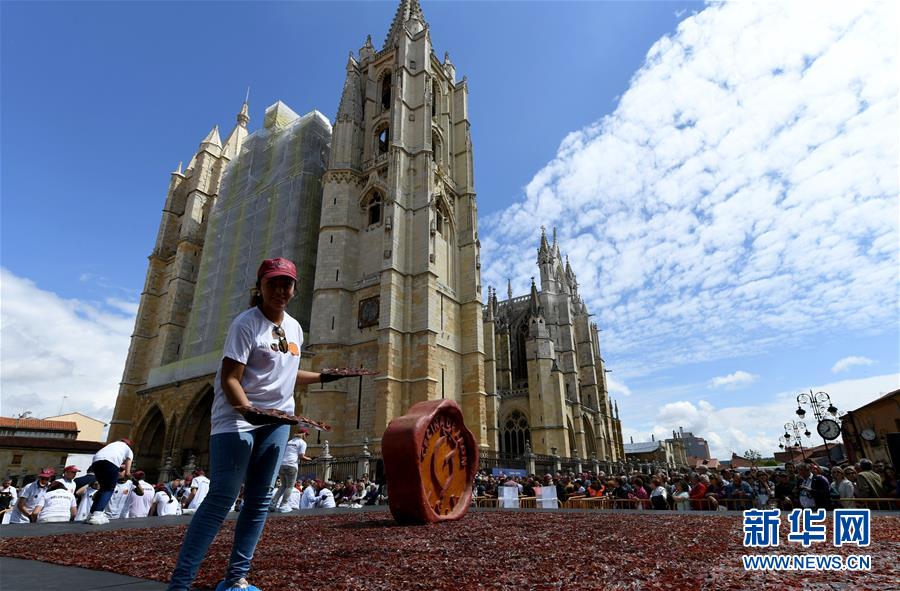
[{"x1": 210, "y1": 307, "x2": 303, "y2": 435}]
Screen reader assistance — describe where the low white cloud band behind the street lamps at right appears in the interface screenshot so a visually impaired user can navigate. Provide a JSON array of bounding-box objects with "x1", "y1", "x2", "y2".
[{"x1": 640, "y1": 374, "x2": 900, "y2": 460}]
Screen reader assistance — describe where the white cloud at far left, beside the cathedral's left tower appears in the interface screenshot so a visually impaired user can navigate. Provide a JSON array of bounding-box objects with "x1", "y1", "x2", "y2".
[{"x1": 0, "y1": 268, "x2": 135, "y2": 421}]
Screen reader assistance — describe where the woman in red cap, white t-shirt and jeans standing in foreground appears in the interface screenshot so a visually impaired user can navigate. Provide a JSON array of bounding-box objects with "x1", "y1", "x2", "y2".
[{"x1": 169, "y1": 258, "x2": 346, "y2": 591}]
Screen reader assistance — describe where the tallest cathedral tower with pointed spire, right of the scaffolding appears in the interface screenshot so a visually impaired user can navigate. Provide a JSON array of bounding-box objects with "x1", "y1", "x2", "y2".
[{"x1": 301, "y1": 0, "x2": 488, "y2": 451}]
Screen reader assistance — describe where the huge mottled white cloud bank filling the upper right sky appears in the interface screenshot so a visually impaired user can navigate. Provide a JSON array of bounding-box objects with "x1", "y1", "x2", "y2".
[{"x1": 481, "y1": 2, "x2": 900, "y2": 379}]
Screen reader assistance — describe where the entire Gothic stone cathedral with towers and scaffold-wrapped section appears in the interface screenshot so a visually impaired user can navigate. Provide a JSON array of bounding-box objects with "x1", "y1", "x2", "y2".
[{"x1": 109, "y1": 0, "x2": 624, "y2": 476}]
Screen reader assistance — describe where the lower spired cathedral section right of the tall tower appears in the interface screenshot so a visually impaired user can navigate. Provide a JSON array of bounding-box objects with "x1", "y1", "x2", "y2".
[{"x1": 483, "y1": 230, "x2": 624, "y2": 462}]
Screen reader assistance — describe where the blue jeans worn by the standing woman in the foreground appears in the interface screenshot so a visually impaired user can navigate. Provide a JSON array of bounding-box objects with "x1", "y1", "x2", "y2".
[{"x1": 169, "y1": 425, "x2": 290, "y2": 591}]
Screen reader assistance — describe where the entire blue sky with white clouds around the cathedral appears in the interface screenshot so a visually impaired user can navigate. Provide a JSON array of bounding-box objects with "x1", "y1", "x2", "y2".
[{"x1": 0, "y1": 1, "x2": 900, "y2": 457}]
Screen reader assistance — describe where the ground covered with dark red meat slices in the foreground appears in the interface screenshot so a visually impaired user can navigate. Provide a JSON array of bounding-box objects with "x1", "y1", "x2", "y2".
[{"x1": 0, "y1": 512, "x2": 900, "y2": 591}]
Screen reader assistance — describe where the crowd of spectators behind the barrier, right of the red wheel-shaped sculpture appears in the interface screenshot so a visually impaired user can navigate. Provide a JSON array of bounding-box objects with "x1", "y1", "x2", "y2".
[{"x1": 473, "y1": 459, "x2": 900, "y2": 511}]
